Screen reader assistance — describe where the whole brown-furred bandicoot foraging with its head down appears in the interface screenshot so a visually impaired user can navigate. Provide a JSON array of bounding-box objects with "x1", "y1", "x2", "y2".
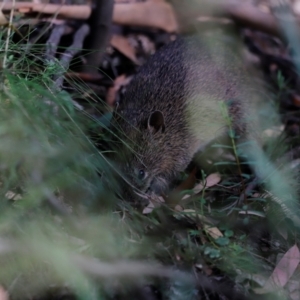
[{"x1": 112, "y1": 38, "x2": 262, "y2": 204}]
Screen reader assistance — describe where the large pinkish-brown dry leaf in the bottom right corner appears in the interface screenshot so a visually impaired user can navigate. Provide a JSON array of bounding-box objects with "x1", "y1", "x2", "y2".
[{"x1": 254, "y1": 245, "x2": 300, "y2": 294}]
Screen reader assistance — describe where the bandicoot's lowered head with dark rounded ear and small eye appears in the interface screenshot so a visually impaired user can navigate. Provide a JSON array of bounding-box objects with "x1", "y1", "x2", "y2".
[{"x1": 112, "y1": 109, "x2": 190, "y2": 206}]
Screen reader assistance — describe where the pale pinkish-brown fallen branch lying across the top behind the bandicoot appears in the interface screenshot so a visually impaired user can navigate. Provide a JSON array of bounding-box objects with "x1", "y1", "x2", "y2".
[{"x1": 0, "y1": 0, "x2": 300, "y2": 36}]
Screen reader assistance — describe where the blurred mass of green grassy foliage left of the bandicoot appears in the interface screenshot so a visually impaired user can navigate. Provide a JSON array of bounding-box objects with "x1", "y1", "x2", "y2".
[{"x1": 0, "y1": 27, "x2": 155, "y2": 299}]
